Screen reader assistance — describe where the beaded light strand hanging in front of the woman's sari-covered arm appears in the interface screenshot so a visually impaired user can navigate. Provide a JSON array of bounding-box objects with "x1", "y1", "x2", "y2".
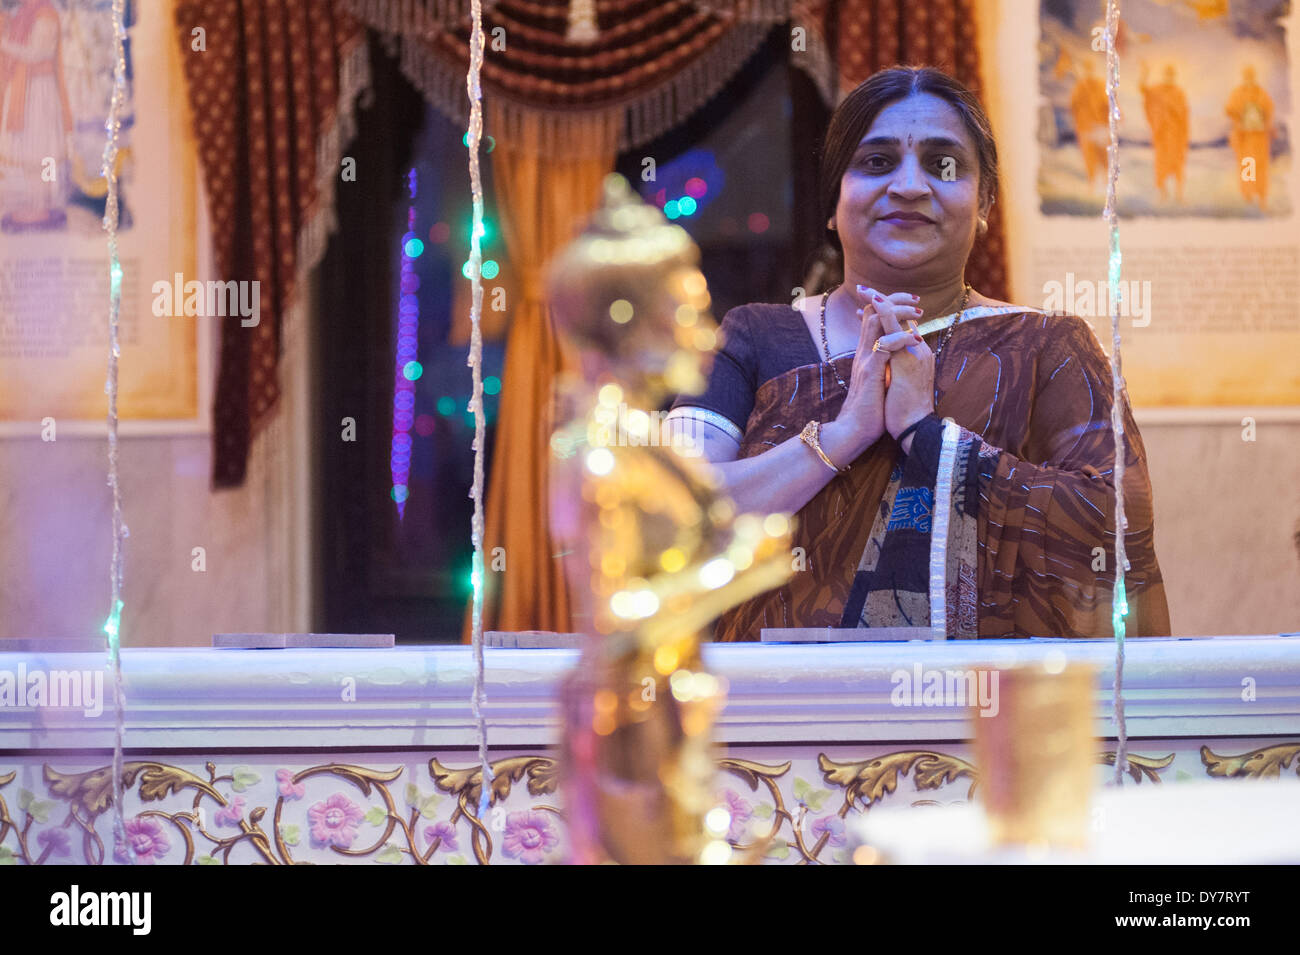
[{"x1": 1105, "y1": 0, "x2": 1128, "y2": 786}]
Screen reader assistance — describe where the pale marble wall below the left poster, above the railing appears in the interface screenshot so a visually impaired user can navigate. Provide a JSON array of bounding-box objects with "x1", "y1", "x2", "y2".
[{"x1": 0, "y1": 435, "x2": 276, "y2": 646}]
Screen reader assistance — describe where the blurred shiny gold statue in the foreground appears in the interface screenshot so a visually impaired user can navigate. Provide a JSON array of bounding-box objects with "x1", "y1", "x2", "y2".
[{"x1": 549, "y1": 174, "x2": 790, "y2": 864}]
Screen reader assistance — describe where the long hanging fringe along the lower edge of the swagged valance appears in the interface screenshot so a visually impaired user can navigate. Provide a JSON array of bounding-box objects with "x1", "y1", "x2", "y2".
[{"x1": 371, "y1": 17, "x2": 768, "y2": 159}]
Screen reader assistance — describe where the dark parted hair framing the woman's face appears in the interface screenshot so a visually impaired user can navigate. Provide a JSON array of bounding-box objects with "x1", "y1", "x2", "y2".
[{"x1": 818, "y1": 66, "x2": 997, "y2": 257}]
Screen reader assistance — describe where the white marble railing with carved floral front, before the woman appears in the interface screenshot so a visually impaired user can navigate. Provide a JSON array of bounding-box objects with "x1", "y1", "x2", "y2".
[{"x1": 0, "y1": 637, "x2": 1300, "y2": 864}]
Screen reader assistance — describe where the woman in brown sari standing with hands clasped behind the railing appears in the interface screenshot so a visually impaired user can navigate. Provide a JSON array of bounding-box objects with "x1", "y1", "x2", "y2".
[{"x1": 670, "y1": 68, "x2": 1170, "y2": 641}]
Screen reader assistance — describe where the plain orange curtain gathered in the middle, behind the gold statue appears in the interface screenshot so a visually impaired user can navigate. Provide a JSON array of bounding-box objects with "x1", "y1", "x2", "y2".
[{"x1": 465, "y1": 99, "x2": 621, "y2": 639}]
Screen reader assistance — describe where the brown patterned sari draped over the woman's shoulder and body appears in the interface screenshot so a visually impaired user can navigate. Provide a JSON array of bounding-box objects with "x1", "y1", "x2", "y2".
[{"x1": 714, "y1": 307, "x2": 1170, "y2": 641}]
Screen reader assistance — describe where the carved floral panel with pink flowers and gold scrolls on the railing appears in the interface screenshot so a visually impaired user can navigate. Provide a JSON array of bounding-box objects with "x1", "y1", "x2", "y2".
[{"x1": 0, "y1": 741, "x2": 1300, "y2": 865}]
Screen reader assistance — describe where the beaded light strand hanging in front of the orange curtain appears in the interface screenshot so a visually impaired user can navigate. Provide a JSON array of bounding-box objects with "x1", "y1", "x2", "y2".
[{"x1": 465, "y1": 0, "x2": 493, "y2": 819}]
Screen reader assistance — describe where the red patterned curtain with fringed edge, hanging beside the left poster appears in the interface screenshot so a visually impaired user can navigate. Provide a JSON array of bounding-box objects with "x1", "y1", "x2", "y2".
[{"x1": 176, "y1": 0, "x2": 368, "y2": 487}]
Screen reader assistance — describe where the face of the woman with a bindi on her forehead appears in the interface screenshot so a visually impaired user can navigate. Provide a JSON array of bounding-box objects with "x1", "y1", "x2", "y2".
[{"x1": 835, "y1": 94, "x2": 987, "y2": 281}]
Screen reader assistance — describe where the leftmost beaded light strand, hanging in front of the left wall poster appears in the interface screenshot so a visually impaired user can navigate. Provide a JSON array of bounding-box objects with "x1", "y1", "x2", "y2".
[{"x1": 103, "y1": 0, "x2": 135, "y2": 864}]
